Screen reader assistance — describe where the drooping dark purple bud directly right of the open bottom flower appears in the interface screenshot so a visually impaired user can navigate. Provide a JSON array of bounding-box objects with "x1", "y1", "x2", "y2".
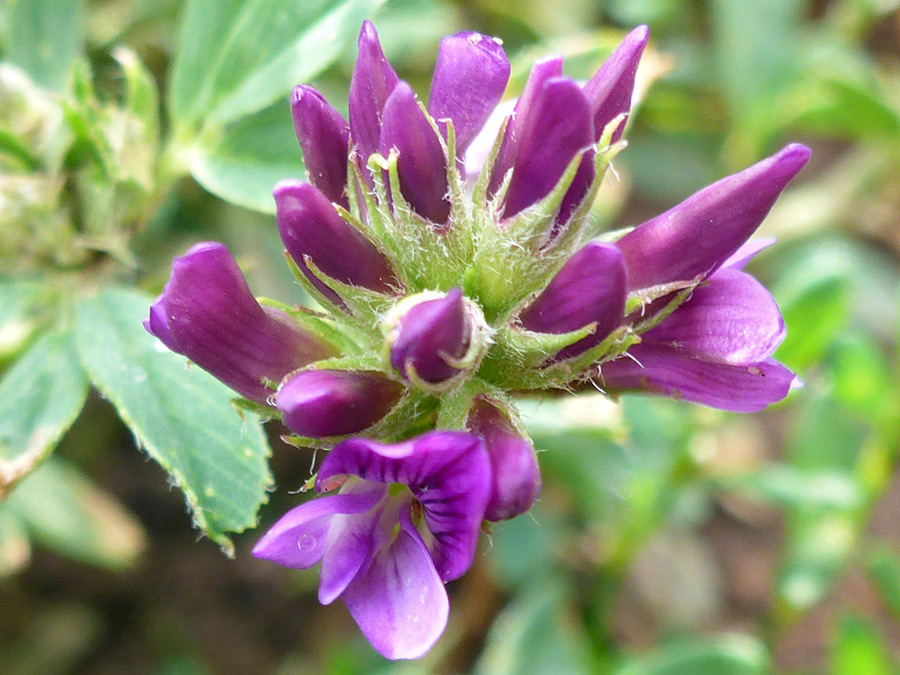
[{"x1": 467, "y1": 398, "x2": 541, "y2": 521}]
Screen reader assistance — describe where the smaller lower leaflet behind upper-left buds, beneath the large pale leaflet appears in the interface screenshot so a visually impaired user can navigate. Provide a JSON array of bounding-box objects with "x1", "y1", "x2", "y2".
[{"x1": 188, "y1": 103, "x2": 304, "y2": 213}]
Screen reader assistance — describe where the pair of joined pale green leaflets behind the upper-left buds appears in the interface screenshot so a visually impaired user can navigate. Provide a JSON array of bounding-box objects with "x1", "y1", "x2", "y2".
[{"x1": 169, "y1": 0, "x2": 384, "y2": 213}]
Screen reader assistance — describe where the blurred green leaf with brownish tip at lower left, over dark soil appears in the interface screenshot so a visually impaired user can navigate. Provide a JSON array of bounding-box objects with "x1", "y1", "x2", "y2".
[{"x1": 0, "y1": 457, "x2": 145, "y2": 569}]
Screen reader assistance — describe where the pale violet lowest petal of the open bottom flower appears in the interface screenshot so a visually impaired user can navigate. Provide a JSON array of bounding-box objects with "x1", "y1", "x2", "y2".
[{"x1": 343, "y1": 508, "x2": 450, "y2": 659}]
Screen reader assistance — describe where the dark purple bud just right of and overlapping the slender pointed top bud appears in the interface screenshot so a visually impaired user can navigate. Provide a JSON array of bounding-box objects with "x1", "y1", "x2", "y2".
[{"x1": 380, "y1": 82, "x2": 450, "y2": 225}]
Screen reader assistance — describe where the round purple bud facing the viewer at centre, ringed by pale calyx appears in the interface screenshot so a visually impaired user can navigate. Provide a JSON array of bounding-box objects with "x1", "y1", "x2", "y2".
[{"x1": 388, "y1": 288, "x2": 484, "y2": 386}]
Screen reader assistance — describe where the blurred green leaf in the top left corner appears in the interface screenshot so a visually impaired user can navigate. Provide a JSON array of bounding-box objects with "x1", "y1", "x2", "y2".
[{"x1": 5, "y1": 0, "x2": 84, "y2": 91}]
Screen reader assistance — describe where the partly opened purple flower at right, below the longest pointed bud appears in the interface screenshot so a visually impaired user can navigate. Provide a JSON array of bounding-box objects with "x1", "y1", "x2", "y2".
[{"x1": 600, "y1": 254, "x2": 797, "y2": 412}]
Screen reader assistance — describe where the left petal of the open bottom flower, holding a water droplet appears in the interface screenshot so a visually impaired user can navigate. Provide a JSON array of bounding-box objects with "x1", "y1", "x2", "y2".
[{"x1": 253, "y1": 490, "x2": 382, "y2": 569}]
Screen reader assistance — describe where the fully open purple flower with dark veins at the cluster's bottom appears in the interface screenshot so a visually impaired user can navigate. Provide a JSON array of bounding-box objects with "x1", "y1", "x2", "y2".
[{"x1": 253, "y1": 431, "x2": 491, "y2": 659}]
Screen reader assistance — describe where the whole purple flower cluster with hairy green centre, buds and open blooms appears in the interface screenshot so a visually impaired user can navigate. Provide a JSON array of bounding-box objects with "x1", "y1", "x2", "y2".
[{"x1": 146, "y1": 22, "x2": 809, "y2": 658}]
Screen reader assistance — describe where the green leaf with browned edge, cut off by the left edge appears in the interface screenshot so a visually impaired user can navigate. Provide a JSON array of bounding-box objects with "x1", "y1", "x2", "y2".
[{"x1": 0, "y1": 331, "x2": 88, "y2": 497}]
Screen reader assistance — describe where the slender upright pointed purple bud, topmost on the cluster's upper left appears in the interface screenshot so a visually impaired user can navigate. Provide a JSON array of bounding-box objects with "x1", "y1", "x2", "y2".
[{"x1": 350, "y1": 21, "x2": 400, "y2": 168}]
